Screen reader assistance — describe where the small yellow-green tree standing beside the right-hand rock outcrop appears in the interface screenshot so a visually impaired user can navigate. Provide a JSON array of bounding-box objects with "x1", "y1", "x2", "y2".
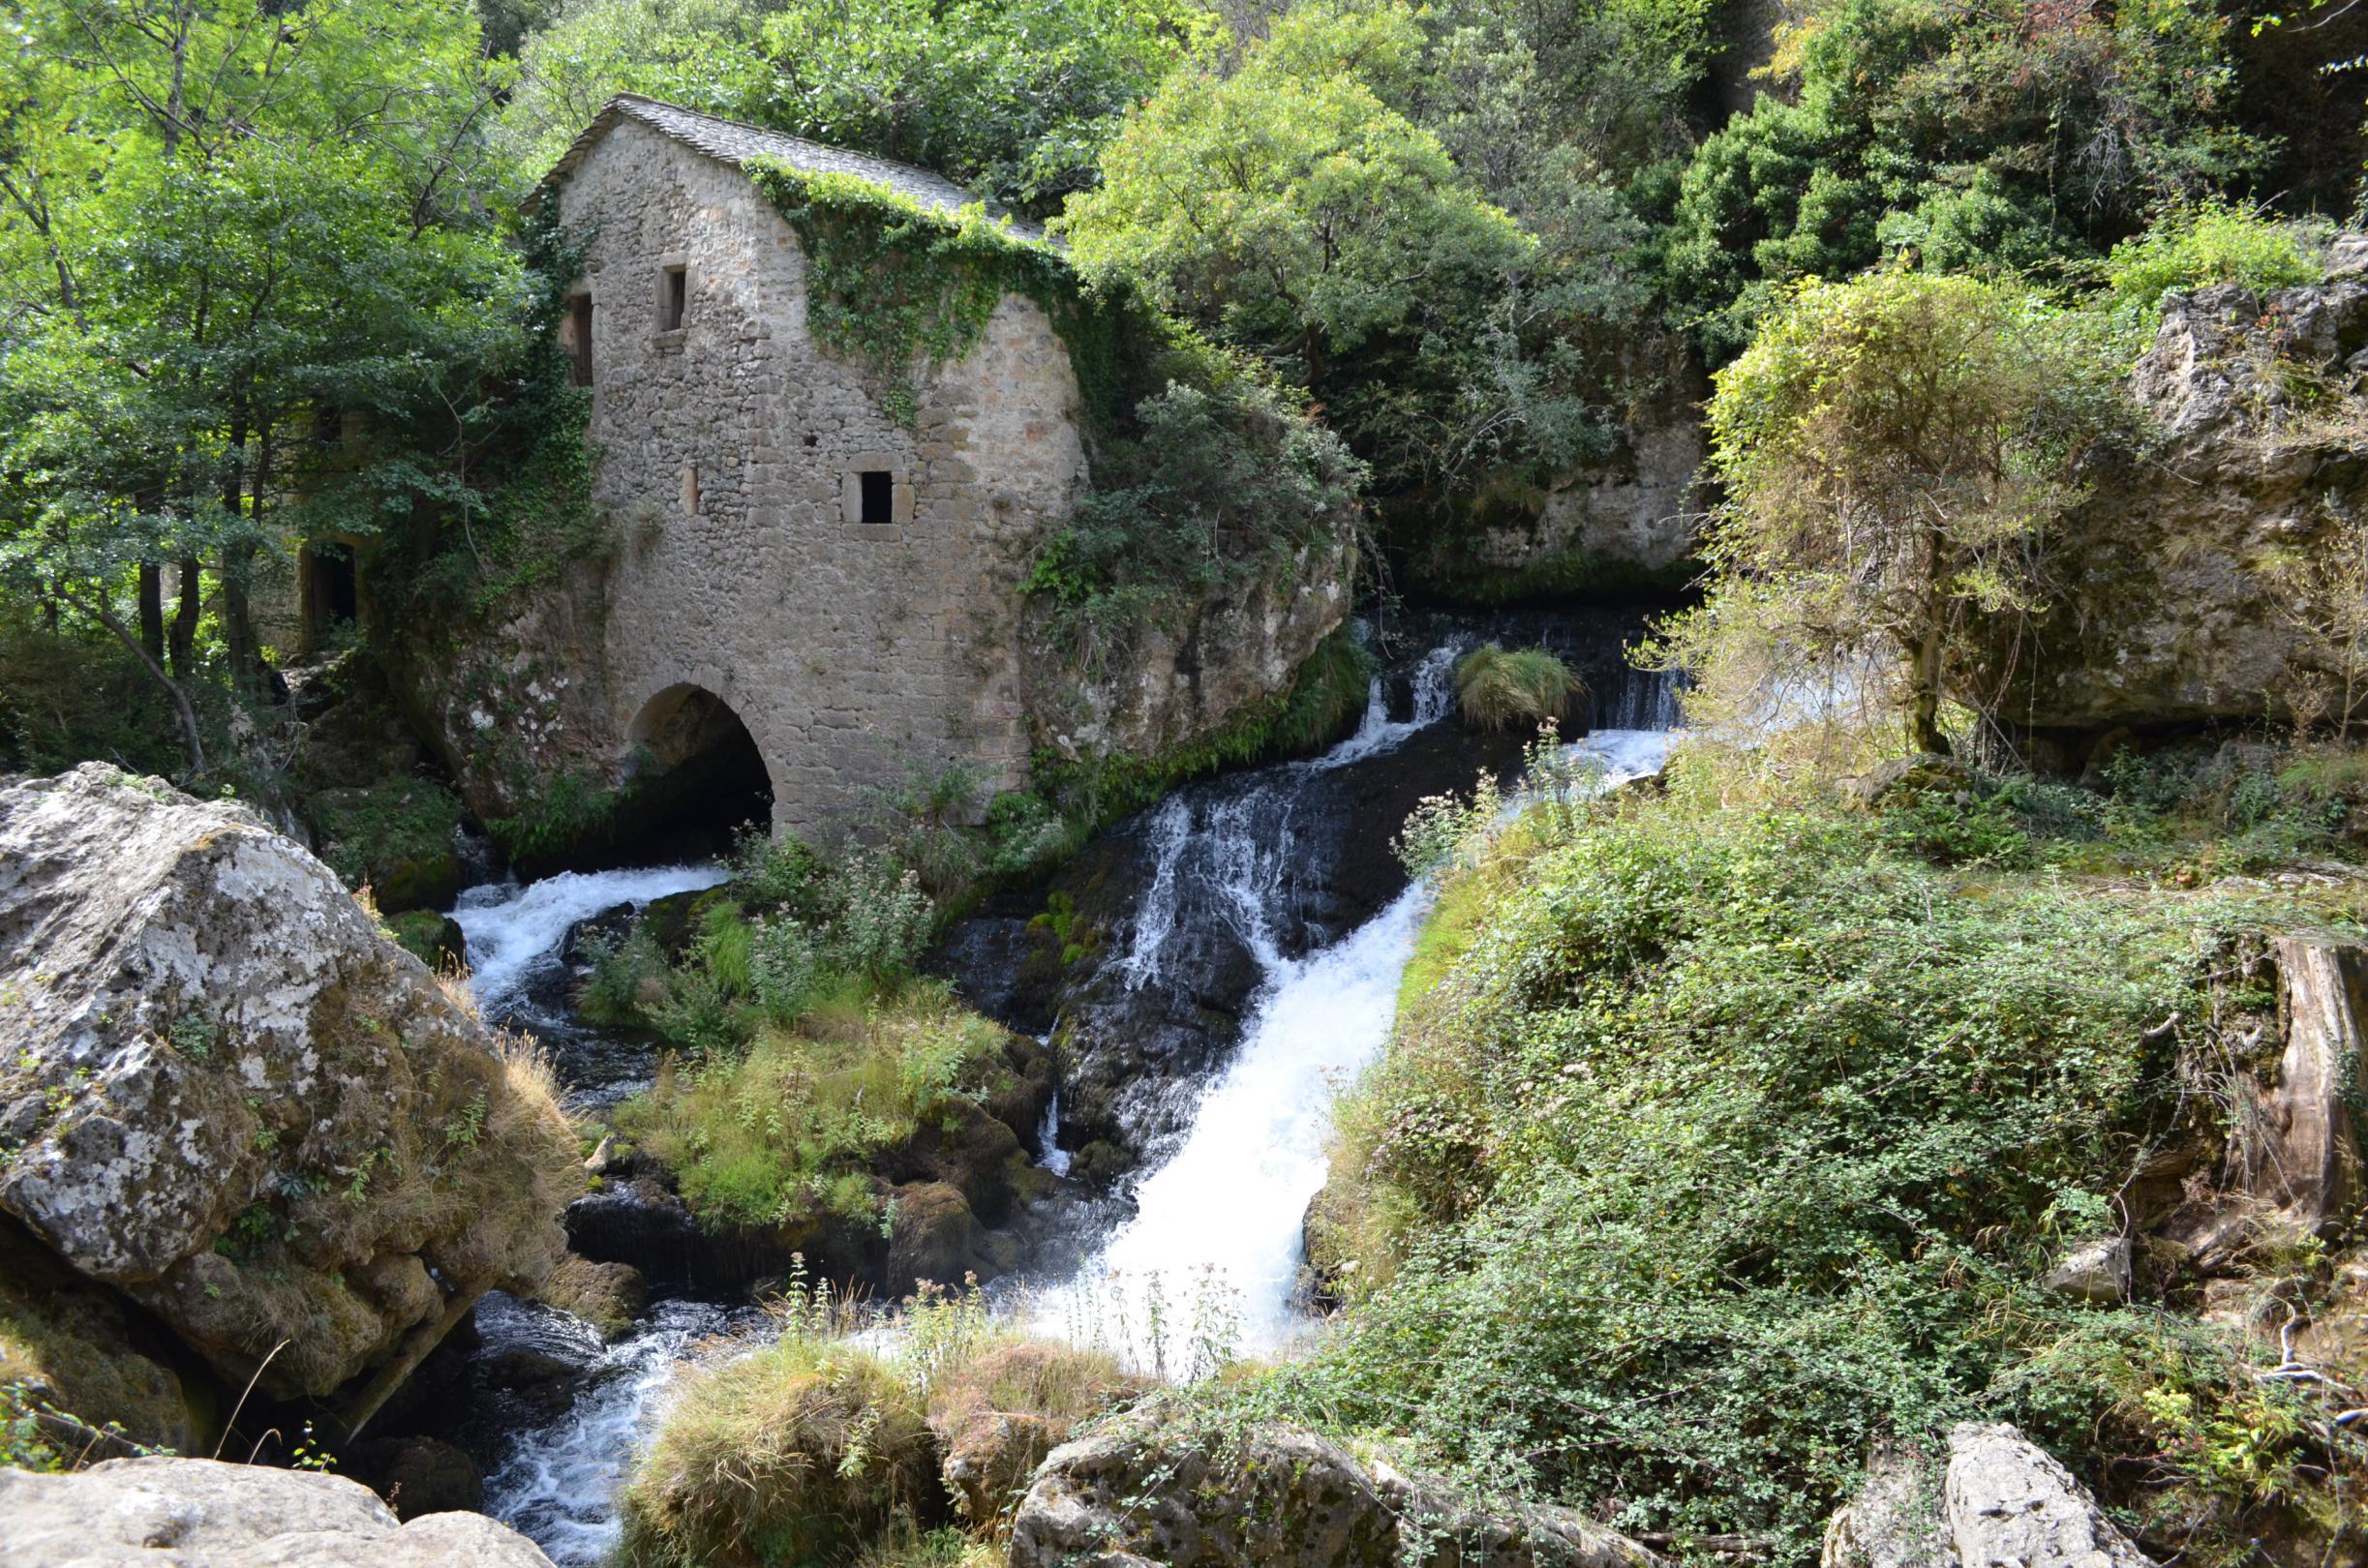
[{"x1": 1682, "y1": 270, "x2": 2086, "y2": 751}]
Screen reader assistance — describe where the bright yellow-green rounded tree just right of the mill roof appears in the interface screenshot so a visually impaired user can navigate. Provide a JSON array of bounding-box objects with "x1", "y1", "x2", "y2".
[{"x1": 1061, "y1": 0, "x2": 1572, "y2": 483}]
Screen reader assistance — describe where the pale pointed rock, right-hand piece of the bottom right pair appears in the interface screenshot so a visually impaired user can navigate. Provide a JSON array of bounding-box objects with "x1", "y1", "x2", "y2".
[{"x1": 1947, "y1": 1421, "x2": 2152, "y2": 1568}]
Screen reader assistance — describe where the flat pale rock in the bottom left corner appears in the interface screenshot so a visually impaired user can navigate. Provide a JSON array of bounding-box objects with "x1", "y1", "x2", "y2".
[{"x1": 0, "y1": 1459, "x2": 552, "y2": 1568}]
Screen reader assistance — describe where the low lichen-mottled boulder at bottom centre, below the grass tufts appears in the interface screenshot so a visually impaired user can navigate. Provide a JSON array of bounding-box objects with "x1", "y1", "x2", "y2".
[{"x1": 1011, "y1": 1411, "x2": 1660, "y2": 1568}]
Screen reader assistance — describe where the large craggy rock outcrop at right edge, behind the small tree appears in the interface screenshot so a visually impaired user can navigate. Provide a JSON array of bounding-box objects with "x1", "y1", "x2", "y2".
[{"x1": 2003, "y1": 252, "x2": 2368, "y2": 732}]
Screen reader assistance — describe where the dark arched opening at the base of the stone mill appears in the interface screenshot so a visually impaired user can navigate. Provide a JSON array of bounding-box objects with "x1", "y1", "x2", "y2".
[{"x1": 625, "y1": 684, "x2": 772, "y2": 858}]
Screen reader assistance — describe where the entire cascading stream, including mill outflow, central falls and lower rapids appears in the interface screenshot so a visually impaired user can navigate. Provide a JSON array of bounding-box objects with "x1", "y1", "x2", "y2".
[{"x1": 431, "y1": 616, "x2": 1674, "y2": 1568}]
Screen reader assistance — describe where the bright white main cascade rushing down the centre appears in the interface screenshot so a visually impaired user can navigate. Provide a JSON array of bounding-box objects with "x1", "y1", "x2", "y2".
[{"x1": 1035, "y1": 706, "x2": 1674, "y2": 1376}]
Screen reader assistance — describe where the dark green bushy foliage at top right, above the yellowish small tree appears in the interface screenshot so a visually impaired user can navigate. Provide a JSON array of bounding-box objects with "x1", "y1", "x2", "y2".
[{"x1": 1662, "y1": 0, "x2": 2263, "y2": 360}]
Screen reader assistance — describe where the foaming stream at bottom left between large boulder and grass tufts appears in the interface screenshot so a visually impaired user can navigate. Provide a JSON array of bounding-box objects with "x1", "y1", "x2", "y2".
[{"x1": 478, "y1": 1296, "x2": 763, "y2": 1568}]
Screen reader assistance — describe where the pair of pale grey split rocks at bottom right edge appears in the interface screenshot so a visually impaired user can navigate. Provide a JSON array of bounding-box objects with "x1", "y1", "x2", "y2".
[{"x1": 1819, "y1": 1421, "x2": 2152, "y2": 1568}]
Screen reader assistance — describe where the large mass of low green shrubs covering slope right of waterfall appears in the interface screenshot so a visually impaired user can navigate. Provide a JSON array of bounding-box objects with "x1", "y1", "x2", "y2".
[{"x1": 1269, "y1": 799, "x2": 2339, "y2": 1563}]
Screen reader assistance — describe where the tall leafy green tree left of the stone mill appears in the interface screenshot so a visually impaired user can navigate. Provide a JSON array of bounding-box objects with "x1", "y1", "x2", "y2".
[{"x1": 0, "y1": 0, "x2": 521, "y2": 772}]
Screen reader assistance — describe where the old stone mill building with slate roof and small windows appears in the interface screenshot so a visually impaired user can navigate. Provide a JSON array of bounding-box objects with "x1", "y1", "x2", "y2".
[{"x1": 540, "y1": 95, "x2": 1087, "y2": 831}]
